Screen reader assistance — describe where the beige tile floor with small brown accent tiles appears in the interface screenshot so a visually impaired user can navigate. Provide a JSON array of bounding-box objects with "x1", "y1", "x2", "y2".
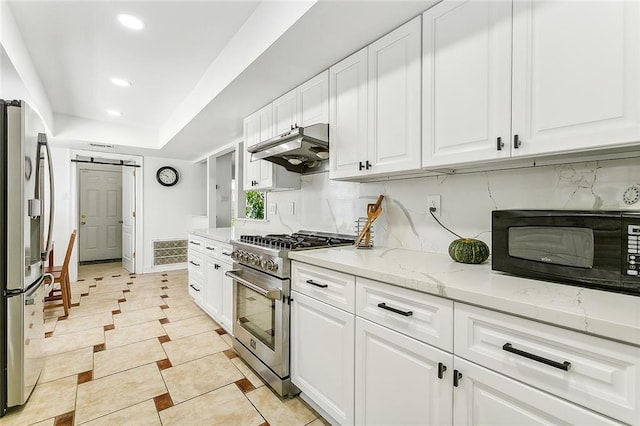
[{"x1": 0, "y1": 263, "x2": 327, "y2": 426}]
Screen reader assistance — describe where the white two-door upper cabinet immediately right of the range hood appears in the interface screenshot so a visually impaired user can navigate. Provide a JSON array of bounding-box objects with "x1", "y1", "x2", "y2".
[{"x1": 329, "y1": 16, "x2": 422, "y2": 180}]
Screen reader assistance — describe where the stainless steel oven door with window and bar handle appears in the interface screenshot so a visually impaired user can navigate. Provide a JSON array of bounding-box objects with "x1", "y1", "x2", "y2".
[{"x1": 226, "y1": 264, "x2": 289, "y2": 377}]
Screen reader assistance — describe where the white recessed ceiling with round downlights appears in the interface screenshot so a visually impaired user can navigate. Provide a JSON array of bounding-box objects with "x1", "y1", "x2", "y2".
[{"x1": 9, "y1": 0, "x2": 435, "y2": 160}]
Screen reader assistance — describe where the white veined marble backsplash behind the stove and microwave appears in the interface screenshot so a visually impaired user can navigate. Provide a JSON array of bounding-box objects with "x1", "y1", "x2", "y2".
[{"x1": 235, "y1": 158, "x2": 640, "y2": 253}]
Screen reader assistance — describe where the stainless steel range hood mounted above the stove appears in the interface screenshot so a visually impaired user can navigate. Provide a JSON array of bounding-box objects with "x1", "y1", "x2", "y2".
[{"x1": 247, "y1": 123, "x2": 329, "y2": 174}]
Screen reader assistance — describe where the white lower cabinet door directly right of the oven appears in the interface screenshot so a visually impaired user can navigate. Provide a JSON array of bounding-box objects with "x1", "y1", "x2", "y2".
[{"x1": 291, "y1": 291, "x2": 355, "y2": 424}]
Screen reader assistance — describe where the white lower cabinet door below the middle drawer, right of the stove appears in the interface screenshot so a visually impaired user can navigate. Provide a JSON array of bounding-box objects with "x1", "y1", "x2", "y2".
[{"x1": 355, "y1": 318, "x2": 453, "y2": 425}]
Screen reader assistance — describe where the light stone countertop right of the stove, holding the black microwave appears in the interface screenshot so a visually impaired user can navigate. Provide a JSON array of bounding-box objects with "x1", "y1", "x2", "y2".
[{"x1": 289, "y1": 246, "x2": 640, "y2": 346}]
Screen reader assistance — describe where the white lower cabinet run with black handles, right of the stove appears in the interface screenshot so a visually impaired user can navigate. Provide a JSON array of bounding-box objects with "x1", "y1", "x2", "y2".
[{"x1": 291, "y1": 262, "x2": 640, "y2": 426}]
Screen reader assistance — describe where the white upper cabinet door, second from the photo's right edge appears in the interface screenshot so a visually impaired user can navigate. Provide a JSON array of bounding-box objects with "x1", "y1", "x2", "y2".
[{"x1": 422, "y1": 0, "x2": 511, "y2": 168}]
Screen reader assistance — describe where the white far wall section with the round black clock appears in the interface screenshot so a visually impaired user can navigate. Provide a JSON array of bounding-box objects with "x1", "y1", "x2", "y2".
[{"x1": 143, "y1": 157, "x2": 207, "y2": 272}]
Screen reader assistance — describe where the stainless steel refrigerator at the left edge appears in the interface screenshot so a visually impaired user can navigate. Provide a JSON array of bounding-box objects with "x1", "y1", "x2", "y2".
[{"x1": 0, "y1": 100, "x2": 54, "y2": 416}]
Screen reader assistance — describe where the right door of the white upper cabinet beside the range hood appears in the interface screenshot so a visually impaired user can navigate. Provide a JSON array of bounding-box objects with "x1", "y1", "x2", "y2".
[{"x1": 365, "y1": 16, "x2": 422, "y2": 173}]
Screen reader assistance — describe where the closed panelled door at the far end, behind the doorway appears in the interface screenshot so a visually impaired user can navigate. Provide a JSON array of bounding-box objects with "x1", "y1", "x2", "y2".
[{"x1": 78, "y1": 165, "x2": 123, "y2": 265}]
